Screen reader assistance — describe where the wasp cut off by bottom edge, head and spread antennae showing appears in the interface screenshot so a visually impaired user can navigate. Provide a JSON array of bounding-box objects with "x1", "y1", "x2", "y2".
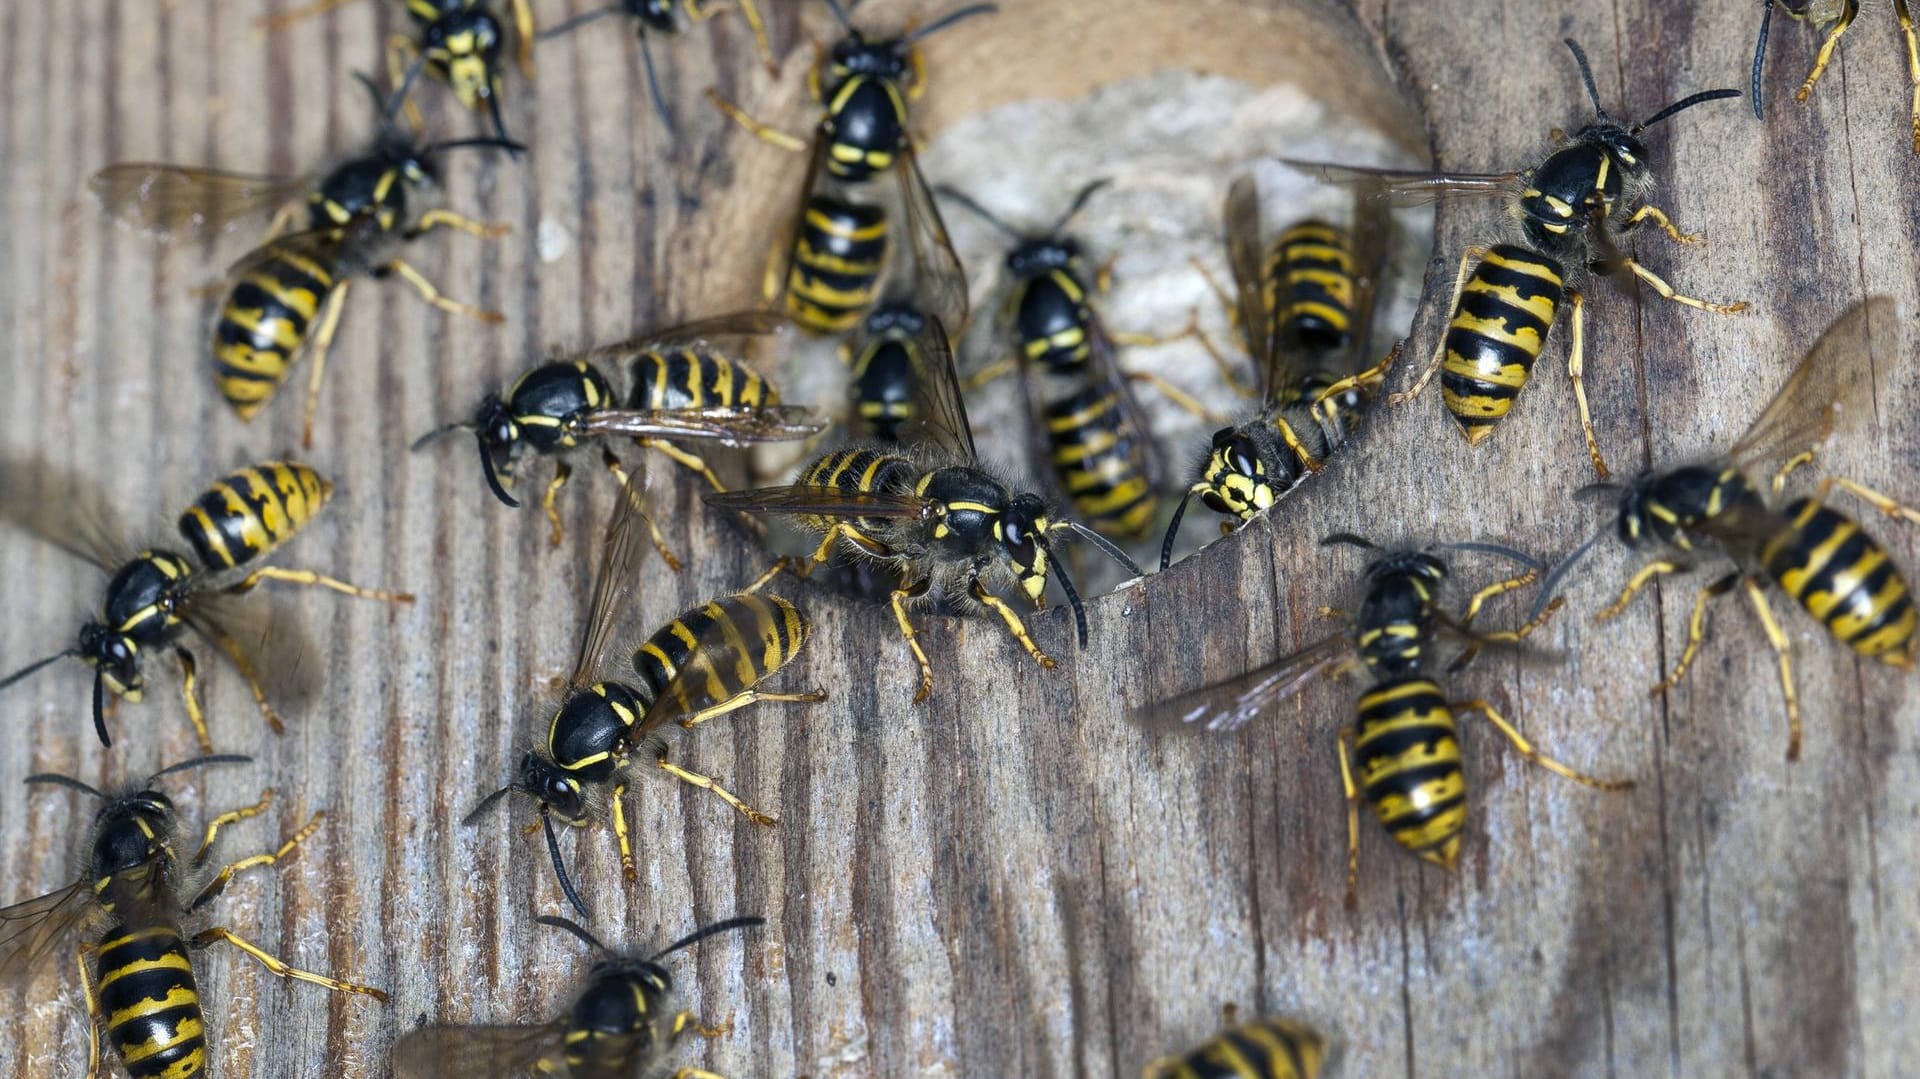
[{"x1": 394, "y1": 918, "x2": 766, "y2": 1079}]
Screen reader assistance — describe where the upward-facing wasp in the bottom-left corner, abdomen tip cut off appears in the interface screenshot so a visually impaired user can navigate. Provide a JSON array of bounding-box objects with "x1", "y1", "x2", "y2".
[{"x1": 0, "y1": 755, "x2": 386, "y2": 1079}]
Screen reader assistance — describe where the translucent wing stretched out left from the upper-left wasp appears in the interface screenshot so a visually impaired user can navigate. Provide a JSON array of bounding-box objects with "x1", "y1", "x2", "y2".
[{"x1": 86, "y1": 161, "x2": 311, "y2": 234}]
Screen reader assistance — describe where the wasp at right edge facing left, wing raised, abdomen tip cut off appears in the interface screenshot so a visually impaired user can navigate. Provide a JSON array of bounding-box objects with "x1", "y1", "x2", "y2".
[{"x1": 1549, "y1": 298, "x2": 1920, "y2": 760}]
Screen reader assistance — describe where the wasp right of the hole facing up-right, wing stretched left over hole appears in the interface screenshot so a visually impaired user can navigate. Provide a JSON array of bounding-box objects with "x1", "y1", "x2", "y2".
[{"x1": 1286, "y1": 38, "x2": 1747, "y2": 480}]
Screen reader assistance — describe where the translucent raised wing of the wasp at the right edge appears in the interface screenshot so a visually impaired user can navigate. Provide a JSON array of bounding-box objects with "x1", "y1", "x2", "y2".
[{"x1": 1728, "y1": 296, "x2": 1897, "y2": 467}]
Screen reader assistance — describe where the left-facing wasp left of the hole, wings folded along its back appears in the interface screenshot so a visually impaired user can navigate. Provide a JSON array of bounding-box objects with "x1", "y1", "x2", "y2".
[{"x1": 413, "y1": 311, "x2": 826, "y2": 549}]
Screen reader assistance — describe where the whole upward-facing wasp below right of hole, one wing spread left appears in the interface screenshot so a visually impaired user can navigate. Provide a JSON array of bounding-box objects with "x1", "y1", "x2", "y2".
[{"x1": 1148, "y1": 534, "x2": 1632, "y2": 906}]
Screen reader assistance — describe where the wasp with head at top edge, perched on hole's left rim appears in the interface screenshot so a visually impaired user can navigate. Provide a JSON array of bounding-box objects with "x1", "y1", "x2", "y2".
[{"x1": 708, "y1": 0, "x2": 998, "y2": 334}]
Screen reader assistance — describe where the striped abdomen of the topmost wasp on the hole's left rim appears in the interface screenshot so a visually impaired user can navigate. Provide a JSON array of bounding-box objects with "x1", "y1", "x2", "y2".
[{"x1": 785, "y1": 196, "x2": 887, "y2": 334}]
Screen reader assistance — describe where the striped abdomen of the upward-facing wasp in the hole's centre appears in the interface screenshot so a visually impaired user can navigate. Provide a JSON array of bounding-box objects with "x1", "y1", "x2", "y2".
[{"x1": 1043, "y1": 386, "x2": 1160, "y2": 536}]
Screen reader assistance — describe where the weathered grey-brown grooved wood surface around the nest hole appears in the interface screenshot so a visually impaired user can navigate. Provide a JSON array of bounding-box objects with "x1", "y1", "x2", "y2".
[{"x1": 0, "y1": 0, "x2": 1920, "y2": 1079}]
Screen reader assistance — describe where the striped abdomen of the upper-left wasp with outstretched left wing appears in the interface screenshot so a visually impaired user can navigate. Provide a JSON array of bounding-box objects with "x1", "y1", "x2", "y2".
[{"x1": 213, "y1": 246, "x2": 340, "y2": 420}]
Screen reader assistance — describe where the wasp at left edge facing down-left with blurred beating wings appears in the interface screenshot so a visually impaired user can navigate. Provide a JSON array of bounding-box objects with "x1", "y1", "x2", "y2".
[{"x1": 0, "y1": 461, "x2": 413, "y2": 751}]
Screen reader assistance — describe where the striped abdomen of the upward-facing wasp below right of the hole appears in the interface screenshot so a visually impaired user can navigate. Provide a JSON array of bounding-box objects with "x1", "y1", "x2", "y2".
[{"x1": 1354, "y1": 676, "x2": 1467, "y2": 868}]
